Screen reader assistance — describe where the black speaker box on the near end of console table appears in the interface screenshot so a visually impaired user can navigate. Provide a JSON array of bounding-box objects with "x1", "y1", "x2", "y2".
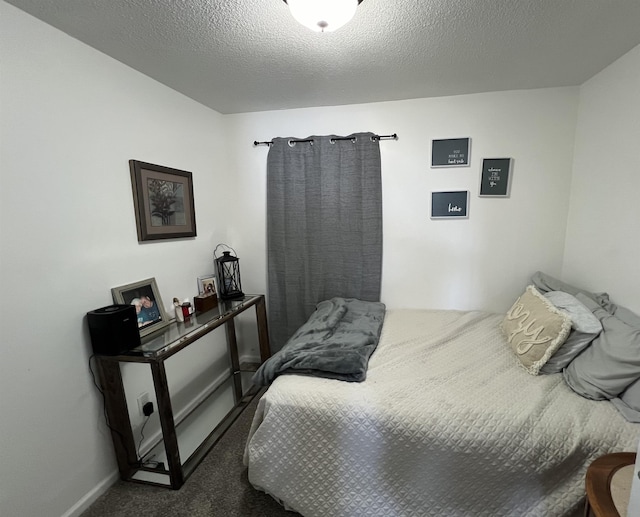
[{"x1": 87, "y1": 305, "x2": 140, "y2": 355}]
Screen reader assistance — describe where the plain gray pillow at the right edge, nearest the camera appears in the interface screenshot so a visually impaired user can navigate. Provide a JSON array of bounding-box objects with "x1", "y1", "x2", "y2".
[{"x1": 563, "y1": 293, "x2": 640, "y2": 400}]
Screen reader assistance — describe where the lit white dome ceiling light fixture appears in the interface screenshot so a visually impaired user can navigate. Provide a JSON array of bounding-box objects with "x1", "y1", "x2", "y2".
[{"x1": 284, "y1": 0, "x2": 362, "y2": 32}]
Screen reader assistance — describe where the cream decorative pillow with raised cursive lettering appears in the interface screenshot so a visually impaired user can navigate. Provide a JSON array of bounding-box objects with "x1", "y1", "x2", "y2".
[{"x1": 501, "y1": 285, "x2": 571, "y2": 375}]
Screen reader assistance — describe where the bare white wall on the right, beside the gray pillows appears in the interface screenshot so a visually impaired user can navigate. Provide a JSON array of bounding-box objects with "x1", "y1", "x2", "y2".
[{"x1": 563, "y1": 46, "x2": 640, "y2": 314}]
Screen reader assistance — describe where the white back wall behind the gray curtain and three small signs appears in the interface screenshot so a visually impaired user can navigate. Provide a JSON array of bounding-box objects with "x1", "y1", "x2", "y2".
[{"x1": 225, "y1": 88, "x2": 578, "y2": 311}]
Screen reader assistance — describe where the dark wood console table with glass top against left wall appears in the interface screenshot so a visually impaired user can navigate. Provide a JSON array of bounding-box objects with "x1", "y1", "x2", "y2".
[{"x1": 96, "y1": 295, "x2": 271, "y2": 489}]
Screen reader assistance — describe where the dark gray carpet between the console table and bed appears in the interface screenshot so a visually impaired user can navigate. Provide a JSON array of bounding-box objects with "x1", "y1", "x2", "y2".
[{"x1": 82, "y1": 397, "x2": 299, "y2": 517}]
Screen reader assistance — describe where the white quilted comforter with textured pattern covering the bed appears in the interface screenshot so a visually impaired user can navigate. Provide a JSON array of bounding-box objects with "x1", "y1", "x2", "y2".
[{"x1": 245, "y1": 310, "x2": 640, "y2": 517}]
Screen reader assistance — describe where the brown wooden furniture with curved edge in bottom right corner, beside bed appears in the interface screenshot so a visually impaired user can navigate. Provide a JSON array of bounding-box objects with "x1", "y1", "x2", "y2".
[{"x1": 584, "y1": 452, "x2": 636, "y2": 517}]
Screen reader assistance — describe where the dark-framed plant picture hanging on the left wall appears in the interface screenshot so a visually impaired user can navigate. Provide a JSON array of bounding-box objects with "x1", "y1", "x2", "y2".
[{"x1": 129, "y1": 160, "x2": 196, "y2": 242}]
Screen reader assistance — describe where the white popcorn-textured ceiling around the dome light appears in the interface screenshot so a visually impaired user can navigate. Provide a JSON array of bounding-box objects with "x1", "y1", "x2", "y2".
[{"x1": 8, "y1": 0, "x2": 640, "y2": 113}]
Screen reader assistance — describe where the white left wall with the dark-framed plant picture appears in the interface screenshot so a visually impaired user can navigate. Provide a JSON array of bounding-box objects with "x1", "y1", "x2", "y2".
[{"x1": 0, "y1": 2, "x2": 233, "y2": 517}]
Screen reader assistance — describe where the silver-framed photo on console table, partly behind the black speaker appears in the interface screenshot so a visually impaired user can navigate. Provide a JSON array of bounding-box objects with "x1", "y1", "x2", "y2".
[{"x1": 111, "y1": 278, "x2": 170, "y2": 337}]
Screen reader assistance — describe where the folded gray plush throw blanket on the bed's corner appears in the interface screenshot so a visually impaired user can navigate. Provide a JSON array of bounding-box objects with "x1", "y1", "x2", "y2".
[{"x1": 252, "y1": 298, "x2": 385, "y2": 386}]
